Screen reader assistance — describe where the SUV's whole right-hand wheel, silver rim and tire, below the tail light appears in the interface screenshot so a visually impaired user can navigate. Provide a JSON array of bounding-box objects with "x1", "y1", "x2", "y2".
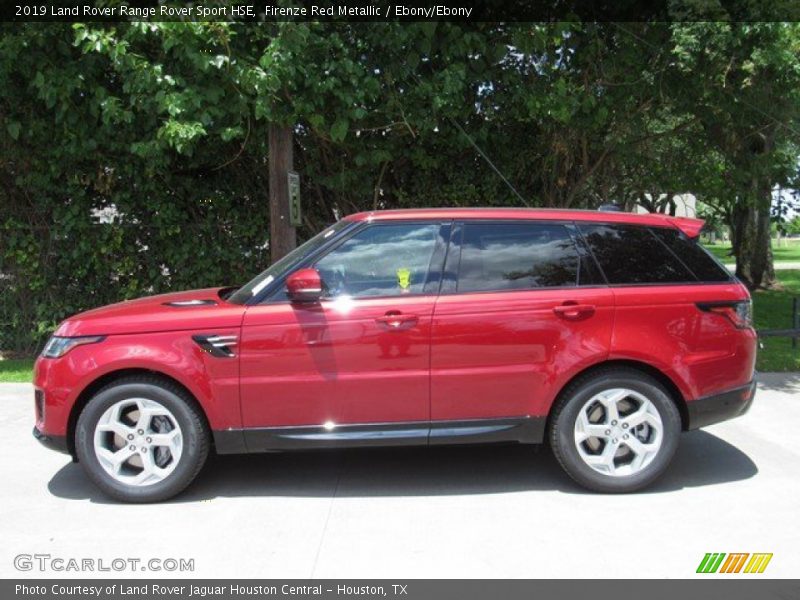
[{"x1": 549, "y1": 369, "x2": 681, "y2": 492}]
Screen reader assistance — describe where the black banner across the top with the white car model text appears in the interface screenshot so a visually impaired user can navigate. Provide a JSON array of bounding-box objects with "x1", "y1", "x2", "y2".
[{"x1": 0, "y1": 0, "x2": 800, "y2": 23}]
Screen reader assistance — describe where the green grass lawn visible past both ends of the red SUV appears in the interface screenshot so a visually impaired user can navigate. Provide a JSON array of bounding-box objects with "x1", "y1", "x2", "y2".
[{"x1": 0, "y1": 272, "x2": 800, "y2": 383}]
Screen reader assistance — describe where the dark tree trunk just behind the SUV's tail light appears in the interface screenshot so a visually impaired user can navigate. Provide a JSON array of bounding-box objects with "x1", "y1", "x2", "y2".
[{"x1": 731, "y1": 182, "x2": 775, "y2": 290}]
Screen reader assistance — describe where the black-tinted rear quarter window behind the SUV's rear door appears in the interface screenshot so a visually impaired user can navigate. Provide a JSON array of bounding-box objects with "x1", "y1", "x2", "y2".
[{"x1": 579, "y1": 225, "x2": 697, "y2": 284}]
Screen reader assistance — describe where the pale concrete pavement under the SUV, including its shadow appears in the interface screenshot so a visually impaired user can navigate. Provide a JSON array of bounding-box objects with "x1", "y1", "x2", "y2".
[{"x1": 0, "y1": 374, "x2": 800, "y2": 578}]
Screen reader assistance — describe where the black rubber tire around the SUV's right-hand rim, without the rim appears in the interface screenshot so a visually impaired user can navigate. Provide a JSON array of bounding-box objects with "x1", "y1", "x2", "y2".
[{"x1": 548, "y1": 368, "x2": 682, "y2": 493}]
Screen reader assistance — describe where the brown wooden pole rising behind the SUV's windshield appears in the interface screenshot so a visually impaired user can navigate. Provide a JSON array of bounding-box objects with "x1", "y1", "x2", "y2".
[{"x1": 269, "y1": 125, "x2": 297, "y2": 262}]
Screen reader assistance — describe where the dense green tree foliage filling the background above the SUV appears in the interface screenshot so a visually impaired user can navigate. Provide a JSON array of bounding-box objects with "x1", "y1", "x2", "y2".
[{"x1": 0, "y1": 22, "x2": 800, "y2": 350}]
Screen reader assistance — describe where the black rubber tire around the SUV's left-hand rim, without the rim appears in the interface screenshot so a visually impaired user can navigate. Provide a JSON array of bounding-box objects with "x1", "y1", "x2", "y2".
[{"x1": 75, "y1": 376, "x2": 210, "y2": 503}]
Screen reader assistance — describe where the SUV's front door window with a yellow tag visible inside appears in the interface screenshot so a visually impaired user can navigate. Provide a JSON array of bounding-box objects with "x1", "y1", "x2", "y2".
[{"x1": 314, "y1": 223, "x2": 440, "y2": 297}]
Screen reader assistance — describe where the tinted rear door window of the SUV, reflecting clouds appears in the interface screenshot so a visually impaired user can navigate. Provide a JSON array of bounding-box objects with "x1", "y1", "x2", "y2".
[{"x1": 457, "y1": 222, "x2": 578, "y2": 292}]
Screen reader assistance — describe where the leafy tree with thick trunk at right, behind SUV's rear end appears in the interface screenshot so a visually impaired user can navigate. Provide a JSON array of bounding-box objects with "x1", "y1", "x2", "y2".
[{"x1": 674, "y1": 23, "x2": 800, "y2": 288}]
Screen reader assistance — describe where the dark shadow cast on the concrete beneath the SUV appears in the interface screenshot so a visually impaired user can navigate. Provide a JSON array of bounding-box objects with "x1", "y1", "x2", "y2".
[{"x1": 48, "y1": 431, "x2": 758, "y2": 503}]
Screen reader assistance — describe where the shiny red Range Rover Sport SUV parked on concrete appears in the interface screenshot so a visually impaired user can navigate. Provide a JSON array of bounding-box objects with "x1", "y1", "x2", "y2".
[{"x1": 34, "y1": 209, "x2": 756, "y2": 502}]
